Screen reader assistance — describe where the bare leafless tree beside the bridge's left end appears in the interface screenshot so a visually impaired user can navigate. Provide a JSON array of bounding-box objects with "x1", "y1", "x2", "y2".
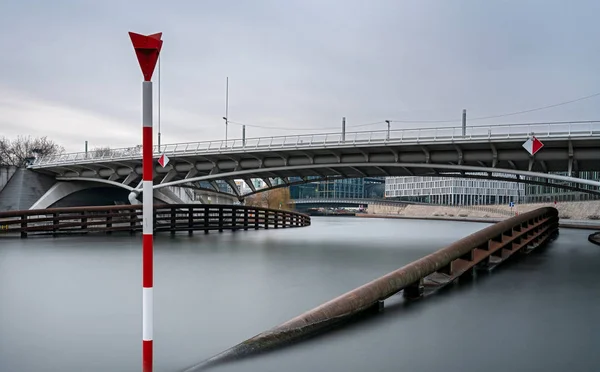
[{"x1": 0, "y1": 136, "x2": 65, "y2": 167}]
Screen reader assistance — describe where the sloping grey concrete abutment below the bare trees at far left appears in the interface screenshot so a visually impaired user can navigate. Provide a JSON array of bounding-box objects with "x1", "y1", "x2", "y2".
[{"x1": 0, "y1": 168, "x2": 56, "y2": 211}]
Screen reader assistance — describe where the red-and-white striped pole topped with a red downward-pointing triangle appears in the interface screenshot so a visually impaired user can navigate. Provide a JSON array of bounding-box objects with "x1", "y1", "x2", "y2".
[{"x1": 129, "y1": 32, "x2": 163, "y2": 372}]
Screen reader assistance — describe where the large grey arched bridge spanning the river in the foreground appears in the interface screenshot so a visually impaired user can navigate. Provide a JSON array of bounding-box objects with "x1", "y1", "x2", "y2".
[{"x1": 21, "y1": 121, "x2": 600, "y2": 208}]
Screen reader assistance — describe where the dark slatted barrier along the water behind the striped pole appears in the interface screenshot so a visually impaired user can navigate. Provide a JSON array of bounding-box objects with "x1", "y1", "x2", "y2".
[{"x1": 0, "y1": 204, "x2": 310, "y2": 238}]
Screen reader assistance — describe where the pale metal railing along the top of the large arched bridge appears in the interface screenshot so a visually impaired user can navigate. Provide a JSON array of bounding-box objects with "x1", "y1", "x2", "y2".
[{"x1": 32, "y1": 121, "x2": 600, "y2": 167}]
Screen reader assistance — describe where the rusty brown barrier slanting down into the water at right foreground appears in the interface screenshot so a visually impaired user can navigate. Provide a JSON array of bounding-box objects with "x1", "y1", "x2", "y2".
[{"x1": 185, "y1": 207, "x2": 558, "y2": 372}]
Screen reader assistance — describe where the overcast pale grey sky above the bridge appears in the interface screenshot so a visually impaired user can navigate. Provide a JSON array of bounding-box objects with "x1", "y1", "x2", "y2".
[{"x1": 0, "y1": 0, "x2": 600, "y2": 151}]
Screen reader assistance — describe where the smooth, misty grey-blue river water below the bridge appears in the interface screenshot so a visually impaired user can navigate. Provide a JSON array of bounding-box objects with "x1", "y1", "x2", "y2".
[{"x1": 0, "y1": 217, "x2": 600, "y2": 372}]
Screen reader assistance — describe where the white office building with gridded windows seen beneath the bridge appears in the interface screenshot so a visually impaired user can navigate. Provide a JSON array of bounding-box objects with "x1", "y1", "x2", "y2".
[{"x1": 385, "y1": 176, "x2": 525, "y2": 205}]
